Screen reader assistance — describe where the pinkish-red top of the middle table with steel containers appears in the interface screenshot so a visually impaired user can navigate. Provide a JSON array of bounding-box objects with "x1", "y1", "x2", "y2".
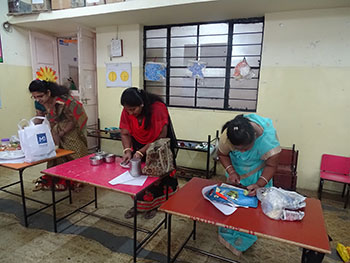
[{"x1": 42, "y1": 155, "x2": 159, "y2": 196}]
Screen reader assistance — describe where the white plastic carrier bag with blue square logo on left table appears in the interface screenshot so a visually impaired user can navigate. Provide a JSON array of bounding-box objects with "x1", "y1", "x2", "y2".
[{"x1": 18, "y1": 117, "x2": 56, "y2": 163}]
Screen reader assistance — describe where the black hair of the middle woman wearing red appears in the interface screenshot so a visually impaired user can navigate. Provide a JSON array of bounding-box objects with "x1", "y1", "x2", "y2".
[{"x1": 120, "y1": 87, "x2": 164, "y2": 129}]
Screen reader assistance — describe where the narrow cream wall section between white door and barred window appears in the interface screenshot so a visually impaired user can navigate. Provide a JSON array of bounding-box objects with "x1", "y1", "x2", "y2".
[{"x1": 96, "y1": 25, "x2": 143, "y2": 154}]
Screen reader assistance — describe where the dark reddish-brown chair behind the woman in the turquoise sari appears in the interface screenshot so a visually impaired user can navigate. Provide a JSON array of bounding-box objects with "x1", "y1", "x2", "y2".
[{"x1": 273, "y1": 144, "x2": 299, "y2": 191}]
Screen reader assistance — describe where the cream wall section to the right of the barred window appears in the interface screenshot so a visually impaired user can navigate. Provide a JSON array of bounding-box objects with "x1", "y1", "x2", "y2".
[{"x1": 258, "y1": 8, "x2": 350, "y2": 189}]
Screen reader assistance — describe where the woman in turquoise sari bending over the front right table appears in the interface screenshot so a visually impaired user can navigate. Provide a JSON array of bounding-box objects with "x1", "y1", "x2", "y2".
[{"x1": 218, "y1": 114, "x2": 281, "y2": 256}]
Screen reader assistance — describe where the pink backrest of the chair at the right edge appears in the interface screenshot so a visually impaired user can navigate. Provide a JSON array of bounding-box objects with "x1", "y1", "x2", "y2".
[{"x1": 320, "y1": 154, "x2": 350, "y2": 175}]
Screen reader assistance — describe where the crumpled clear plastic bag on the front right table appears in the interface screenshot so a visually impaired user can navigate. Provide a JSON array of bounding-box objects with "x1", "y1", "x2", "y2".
[{"x1": 257, "y1": 187, "x2": 306, "y2": 221}]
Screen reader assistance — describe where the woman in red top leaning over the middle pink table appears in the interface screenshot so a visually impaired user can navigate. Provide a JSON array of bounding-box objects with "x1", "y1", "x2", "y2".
[{"x1": 119, "y1": 88, "x2": 178, "y2": 219}]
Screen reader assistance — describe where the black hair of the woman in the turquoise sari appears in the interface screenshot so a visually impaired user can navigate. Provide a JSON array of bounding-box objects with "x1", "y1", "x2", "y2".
[{"x1": 221, "y1": 114, "x2": 255, "y2": 146}]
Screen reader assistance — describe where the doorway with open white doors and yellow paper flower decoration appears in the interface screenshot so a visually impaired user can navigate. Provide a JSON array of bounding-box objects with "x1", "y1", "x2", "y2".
[{"x1": 30, "y1": 28, "x2": 98, "y2": 151}]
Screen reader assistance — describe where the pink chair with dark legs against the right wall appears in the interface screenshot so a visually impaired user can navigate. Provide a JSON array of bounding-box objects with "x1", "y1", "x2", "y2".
[{"x1": 318, "y1": 154, "x2": 350, "y2": 208}]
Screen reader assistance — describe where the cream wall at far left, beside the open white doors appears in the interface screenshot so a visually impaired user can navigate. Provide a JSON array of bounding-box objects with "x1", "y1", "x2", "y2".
[{"x1": 0, "y1": 1, "x2": 34, "y2": 138}]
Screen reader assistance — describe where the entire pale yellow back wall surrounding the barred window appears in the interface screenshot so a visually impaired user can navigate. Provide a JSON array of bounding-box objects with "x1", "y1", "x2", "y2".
[{"x1": 97, "y1": 8, "x2": 350, "y2": 192}]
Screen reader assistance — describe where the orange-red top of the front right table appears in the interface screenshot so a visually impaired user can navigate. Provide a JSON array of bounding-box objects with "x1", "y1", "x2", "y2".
[{"x1": 159, "y1": 178, "x2": 331, "y2": 253}]
